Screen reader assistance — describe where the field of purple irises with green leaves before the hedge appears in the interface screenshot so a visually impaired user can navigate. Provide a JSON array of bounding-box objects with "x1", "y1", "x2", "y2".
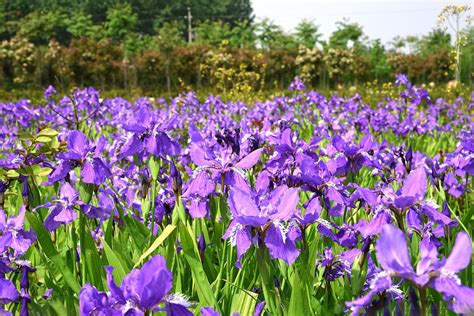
[{"x1": 0, "y1": 75, "x2": 474, "y2": 316}]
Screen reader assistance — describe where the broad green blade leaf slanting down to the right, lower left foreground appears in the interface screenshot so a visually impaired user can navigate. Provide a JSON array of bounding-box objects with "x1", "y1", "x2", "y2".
[{"x1": 26, "y1": 212, "x2": 81, "y2": 293}]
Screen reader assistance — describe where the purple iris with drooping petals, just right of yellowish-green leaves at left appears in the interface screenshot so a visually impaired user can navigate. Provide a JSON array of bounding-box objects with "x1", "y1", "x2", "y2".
[{"x1": 49, "y1": 131, "x2": 112, "y2": 185}]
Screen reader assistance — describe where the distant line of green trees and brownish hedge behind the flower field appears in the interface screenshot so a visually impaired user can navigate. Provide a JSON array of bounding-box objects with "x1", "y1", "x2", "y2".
[{"x1": 0, "y1": 0, "x2": 474, "y2": 91}]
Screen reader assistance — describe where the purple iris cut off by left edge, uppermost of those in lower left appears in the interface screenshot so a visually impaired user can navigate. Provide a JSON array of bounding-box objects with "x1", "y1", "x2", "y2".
[{"x1": 0, "y1": 206, "x2": 36, "y2": 256}]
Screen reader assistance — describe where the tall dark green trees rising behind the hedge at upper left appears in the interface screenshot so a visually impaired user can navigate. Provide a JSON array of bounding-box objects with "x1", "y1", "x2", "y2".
[{"x1": 0, "y1": 0, "x2": 252, "y2": 44}]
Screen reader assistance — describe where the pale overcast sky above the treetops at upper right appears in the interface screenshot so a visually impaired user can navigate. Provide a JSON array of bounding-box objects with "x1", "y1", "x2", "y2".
[{"x1": 252, "y1": 0, "x2": 474, "y2": 43}]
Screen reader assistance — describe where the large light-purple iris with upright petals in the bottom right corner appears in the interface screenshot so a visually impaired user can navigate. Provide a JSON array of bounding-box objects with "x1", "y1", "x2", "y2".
[{"x1": 347, "y1": 224, "x2": 474, "y2": 314}]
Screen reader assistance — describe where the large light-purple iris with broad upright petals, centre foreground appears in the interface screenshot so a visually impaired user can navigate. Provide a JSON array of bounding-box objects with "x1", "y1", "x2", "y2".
[{"x1": 223, "y1": 186, "x2": 301, "y2": 268}]
